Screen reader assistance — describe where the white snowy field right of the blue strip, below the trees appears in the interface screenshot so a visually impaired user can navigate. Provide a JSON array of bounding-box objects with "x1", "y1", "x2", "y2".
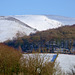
[{"x1": 56, "y1": 54, "x2": 75, "y2": 72}]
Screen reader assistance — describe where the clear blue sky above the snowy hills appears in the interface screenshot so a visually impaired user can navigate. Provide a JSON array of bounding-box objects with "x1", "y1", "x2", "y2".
[{"x1": 0, "y1": 0, "x2": 75, "y2": 17}]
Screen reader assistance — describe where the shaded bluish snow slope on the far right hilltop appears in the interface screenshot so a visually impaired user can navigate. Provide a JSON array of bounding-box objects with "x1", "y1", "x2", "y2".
[{"x1": 45, "y1": 15, "x2": 75, "y2": 25}]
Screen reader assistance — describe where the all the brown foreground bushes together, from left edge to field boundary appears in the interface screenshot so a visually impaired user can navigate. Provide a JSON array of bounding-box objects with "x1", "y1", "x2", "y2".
[{"x1": 0, "y1": 44, "x2": 61, "y2": 75}]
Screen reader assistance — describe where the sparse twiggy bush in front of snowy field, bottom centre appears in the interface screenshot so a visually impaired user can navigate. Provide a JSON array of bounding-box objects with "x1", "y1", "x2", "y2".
[{"x1": 21, "y1": 54, "x2": 61, "y2": 75}]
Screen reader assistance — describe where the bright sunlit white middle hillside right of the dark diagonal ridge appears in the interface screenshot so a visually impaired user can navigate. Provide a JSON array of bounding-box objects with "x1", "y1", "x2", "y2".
[{"x1": 13, "y1": 15, "x2": 62, "y2": 31}]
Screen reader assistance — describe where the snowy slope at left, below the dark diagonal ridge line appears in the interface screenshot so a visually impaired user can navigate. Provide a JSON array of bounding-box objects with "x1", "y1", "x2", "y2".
[{"x1": 0, "y1": 17, "x2": 36, "y2": 42}]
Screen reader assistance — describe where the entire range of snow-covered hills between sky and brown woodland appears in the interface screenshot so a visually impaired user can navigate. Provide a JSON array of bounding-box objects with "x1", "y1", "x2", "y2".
[{"x1": 0, "y1": 15, "x2": 75, "y2": 42}]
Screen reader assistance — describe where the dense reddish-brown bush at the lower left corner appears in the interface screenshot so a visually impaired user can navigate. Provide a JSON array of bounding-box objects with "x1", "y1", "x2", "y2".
[{"x1": 0, "y1": 44, "x2": 21, "y2": 75}]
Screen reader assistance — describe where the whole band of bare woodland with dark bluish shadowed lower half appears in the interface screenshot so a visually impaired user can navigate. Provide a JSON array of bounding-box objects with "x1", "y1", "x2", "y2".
[{"x1": 5, "y1": 25, "x2": 75, "y2": 52}]
